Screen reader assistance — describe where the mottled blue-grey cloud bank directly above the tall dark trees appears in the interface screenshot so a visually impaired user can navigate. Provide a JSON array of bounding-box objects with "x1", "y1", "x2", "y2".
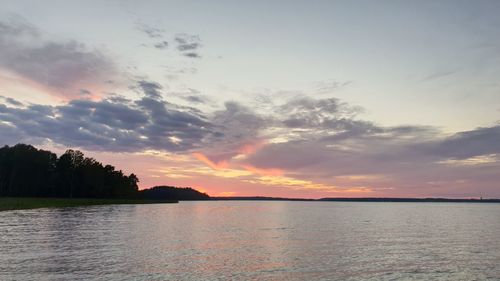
[{"x1": 0, "y1": 81, "x2": 216, "y2": 152}]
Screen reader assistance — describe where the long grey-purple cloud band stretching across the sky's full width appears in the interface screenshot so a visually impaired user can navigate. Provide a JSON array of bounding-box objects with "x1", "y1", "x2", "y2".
[{"x1": 0, "y1": 89, "x2": 500, "y2": 164}]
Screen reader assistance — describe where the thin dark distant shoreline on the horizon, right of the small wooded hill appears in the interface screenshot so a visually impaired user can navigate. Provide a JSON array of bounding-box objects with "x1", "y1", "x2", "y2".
[{"x1": 210, "y1": 196, "x2": 500, "y2": 203}]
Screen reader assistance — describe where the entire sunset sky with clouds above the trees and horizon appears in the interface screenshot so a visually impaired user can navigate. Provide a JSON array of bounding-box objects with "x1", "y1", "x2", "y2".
[{"x1": 0, "y1": 0, "x2": 500, "y2": 198}]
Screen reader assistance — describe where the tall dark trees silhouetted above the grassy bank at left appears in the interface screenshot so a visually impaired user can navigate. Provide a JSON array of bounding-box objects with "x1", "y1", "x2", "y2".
[{"x1": 0, "y1": 144, "x2": 139, "y2": 198}]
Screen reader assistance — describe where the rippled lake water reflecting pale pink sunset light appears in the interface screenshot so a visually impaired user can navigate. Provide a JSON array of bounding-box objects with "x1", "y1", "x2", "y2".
[{"x1": 0, "y1": 201, "x2": 500, "y2": 280}]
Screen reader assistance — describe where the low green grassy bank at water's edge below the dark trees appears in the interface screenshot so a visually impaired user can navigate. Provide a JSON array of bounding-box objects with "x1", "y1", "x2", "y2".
[{"x1": 0, "y1": 197, "x2": 178, "y2": 211}]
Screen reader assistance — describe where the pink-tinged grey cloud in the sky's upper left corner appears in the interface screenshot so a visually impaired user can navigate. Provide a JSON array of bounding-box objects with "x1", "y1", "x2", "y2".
[{"x1": 0, "y1": 16, "x2": 117, "y2": 97}]
